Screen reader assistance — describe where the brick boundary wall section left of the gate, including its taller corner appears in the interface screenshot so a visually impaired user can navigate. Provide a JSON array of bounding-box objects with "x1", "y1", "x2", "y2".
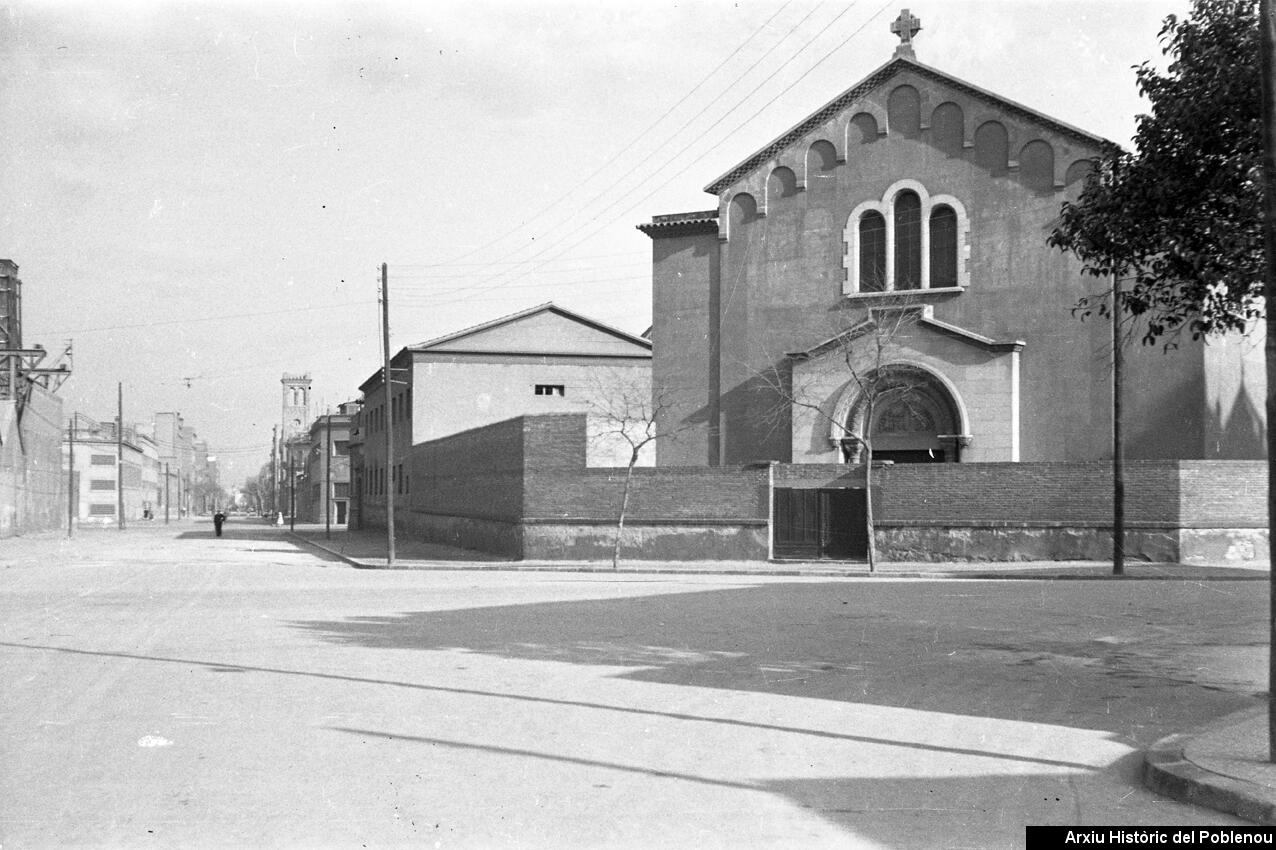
[{"x1": 398, "y1": 414, "x2": 769, "y2": 560}]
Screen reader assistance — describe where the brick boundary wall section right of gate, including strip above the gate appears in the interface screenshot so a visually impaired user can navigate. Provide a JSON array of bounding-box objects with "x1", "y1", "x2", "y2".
[{"x1": 775, "y1": 461, "x2": 1270, "y2": 562}]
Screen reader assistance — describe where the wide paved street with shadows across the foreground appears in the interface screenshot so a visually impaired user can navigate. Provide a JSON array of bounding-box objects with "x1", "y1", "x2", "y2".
[{"x1": 0, "y1": 522, "x2": 1267, "y2": 850}]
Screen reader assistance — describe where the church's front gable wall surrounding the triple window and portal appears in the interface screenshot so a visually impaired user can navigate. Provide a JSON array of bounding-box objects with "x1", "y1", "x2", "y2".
[{"x1": 709, "y1": 71, "x2": 1202, "y2": 463}]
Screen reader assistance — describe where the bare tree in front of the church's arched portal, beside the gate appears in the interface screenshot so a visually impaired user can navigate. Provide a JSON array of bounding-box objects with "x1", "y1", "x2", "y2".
[{"x1": 762, "y1": 306, "x2": 925, "y2": 572}]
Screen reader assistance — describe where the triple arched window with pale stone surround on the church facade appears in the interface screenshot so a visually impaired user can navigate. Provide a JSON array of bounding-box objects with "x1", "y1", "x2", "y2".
[{"x1": 843, "y1": 180, "x2": 967, "y2": 295}]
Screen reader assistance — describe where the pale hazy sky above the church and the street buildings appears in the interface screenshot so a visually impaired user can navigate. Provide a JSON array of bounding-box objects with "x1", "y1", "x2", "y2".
[{"x1": 0, "y1": 0, "x2": 1187, "y2": 486}]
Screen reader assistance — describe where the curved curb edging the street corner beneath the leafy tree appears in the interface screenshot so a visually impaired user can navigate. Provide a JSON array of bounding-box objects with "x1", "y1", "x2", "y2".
[{"x1": 1143, "y1": 734, "x2": 1276, "y2": 824}]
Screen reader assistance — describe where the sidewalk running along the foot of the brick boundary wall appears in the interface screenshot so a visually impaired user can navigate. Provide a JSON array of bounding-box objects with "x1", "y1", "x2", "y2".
[{"x1": 291, "y1": 525, "x2": 1270, "y2": 581}]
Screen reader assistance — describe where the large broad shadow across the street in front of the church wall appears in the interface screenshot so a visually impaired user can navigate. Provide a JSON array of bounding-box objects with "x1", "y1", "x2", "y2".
[{"x1": 284, "y1": 582, "x2": 1266, "y2": 744}]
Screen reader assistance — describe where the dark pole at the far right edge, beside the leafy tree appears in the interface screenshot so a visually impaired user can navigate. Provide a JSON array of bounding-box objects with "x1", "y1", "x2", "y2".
[{"x1": 1258, "y1": 0, "x2": 1276, "y2": 762}]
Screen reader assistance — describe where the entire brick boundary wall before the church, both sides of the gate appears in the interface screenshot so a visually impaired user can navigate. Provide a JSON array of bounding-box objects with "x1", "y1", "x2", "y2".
[{"x1": 385, "y1": 414, "x2": 1268, "y2": 563}]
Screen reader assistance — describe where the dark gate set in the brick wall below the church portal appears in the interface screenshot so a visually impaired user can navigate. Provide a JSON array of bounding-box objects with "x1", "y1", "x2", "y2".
[{"x1": 775, "y1": 488, "x2": 869, "y2": 560}]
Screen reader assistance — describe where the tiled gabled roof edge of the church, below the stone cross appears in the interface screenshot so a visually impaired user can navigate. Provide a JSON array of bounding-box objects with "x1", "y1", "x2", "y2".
[{"x1": 704, "y1": 55, "x2": 1118, "y2": 195}]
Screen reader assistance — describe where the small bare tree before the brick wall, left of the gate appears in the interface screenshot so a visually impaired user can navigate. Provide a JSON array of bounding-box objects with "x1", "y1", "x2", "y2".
[{"x1": 588, "y1": 370, "x2": 690, "y2": 569}]
